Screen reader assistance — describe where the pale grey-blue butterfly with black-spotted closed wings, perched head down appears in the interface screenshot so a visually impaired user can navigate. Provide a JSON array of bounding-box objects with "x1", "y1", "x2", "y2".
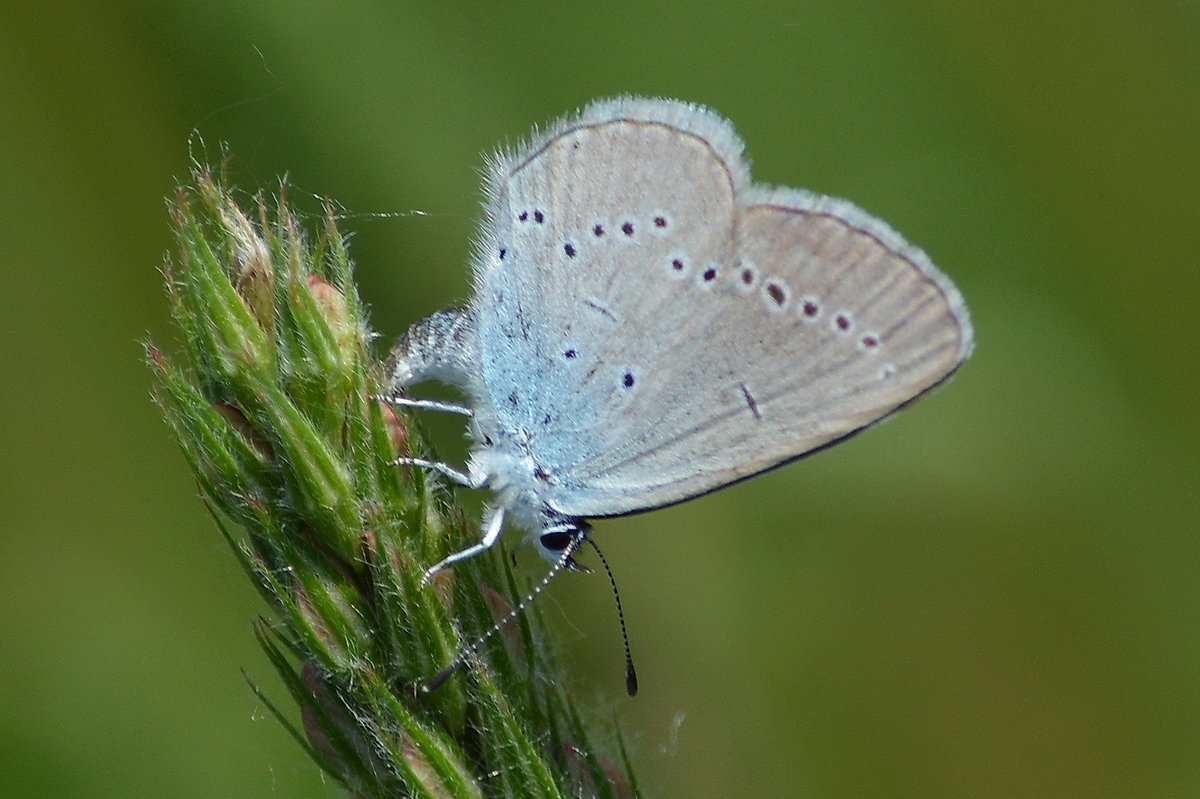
[{"x1": 379, "y1": 97, "x2": 972, "y2": 686}]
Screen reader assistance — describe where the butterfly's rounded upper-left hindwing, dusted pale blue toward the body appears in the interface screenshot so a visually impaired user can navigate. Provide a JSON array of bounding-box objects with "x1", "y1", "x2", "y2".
[{"x1": 476, "y1": 101, "x2": 745, "y2": 458}]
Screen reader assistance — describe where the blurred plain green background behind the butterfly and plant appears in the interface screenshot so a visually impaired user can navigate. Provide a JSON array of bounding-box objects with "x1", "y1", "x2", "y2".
[{"x1": 0, "y1": 0, "x2": 1200, "y2": 798}]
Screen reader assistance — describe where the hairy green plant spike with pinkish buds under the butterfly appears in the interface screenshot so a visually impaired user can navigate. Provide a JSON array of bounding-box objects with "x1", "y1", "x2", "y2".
[{"x1": 148, "y1": 167, "x2": 637, "y2": 797}]
